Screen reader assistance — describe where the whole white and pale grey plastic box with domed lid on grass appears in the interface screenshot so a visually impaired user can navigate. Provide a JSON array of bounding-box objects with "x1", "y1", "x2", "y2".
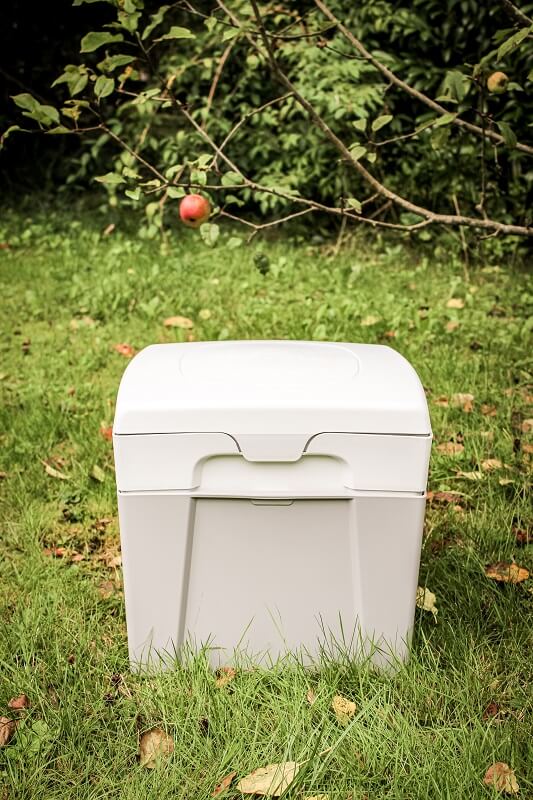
[{"x1": 113, "y1": 341, "x2": 431, "y2": 668}]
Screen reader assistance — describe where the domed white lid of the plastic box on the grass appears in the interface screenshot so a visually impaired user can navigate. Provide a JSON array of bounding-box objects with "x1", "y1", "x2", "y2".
[{"x1": 114, "y1": 341, "x2": 430, "y2": 434}]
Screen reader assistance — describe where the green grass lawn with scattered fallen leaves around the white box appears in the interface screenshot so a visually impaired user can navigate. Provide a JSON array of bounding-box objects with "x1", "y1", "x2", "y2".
[{"x1": 0, "y1": 203, "x2": 533, "y2": 800}]
